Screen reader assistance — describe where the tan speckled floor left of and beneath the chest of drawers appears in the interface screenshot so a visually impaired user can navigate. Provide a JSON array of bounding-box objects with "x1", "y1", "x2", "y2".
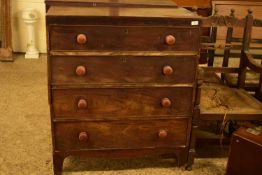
[{"x1": 0, "y1": 55, "x2": 227, "y2": 175}]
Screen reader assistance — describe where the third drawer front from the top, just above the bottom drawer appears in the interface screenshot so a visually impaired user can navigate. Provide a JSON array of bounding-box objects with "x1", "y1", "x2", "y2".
[{"x1": 52, "y1": 87, "x2": 193, "y2": 119}]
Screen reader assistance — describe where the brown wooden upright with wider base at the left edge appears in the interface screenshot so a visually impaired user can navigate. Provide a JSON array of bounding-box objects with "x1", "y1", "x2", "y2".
[{"x1": 0, "y1": 0, "x2": 13, "y2": 61}]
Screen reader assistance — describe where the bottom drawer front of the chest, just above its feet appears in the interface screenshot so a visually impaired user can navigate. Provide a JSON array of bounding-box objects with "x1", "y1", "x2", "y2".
[{"x1": 54, "y1": 118, "x2": 191, "y2": 150}]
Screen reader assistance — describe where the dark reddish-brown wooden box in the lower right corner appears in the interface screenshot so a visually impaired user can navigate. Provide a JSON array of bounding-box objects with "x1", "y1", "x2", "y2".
[{"x1": 226, "y1": 127, "x2": 262, "y2": 175}]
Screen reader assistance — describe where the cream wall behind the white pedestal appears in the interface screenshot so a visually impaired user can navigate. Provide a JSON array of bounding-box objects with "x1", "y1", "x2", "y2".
[{"x1": 11, "y1": 0, "x2": 46, "y2": 53}]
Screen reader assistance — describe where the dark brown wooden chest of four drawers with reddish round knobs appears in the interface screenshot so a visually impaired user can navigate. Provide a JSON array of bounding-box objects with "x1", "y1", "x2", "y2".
[{"x1": 46, "y1": 0, "x2": 200, "y2": 174}]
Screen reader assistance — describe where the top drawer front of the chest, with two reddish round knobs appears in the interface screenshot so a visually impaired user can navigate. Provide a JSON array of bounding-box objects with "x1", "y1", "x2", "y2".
[{"x1": 49, "y1": 26, "x2": 199, "y2": 51}]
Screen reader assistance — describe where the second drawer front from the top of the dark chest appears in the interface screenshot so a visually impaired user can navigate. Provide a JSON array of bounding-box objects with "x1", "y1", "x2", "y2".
[{"x1": 51, "y1": 56, "x2": 197, "y2": 84}]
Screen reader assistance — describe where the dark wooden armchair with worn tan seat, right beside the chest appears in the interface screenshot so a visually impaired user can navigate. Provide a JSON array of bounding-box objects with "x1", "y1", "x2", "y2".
[{"x1": 198, "y1": 11, "x2": 262, "y2": 143}]
